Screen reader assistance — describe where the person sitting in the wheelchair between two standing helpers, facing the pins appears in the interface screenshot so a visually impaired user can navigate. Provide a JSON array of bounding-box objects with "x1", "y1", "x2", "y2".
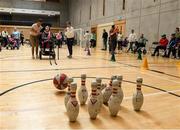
[{"x1": 41, "y1": 26, "x2": 53, "y2": 51}]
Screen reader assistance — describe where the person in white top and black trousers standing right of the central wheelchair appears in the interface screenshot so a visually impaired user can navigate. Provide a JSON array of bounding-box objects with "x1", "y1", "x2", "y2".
[{"x1": 65, "y1": 22, "x2": 74, "y2": 58}]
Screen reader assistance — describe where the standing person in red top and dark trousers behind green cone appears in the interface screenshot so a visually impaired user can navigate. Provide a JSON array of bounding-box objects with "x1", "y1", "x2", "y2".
[{"x1": 110, "y1": 25, "x2": 119, "y2": 54}]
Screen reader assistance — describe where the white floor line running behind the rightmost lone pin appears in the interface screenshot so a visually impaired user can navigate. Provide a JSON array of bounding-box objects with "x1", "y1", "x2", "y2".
[{"x1": 124, "y1": 89, "x2": 180, "y2": 100}]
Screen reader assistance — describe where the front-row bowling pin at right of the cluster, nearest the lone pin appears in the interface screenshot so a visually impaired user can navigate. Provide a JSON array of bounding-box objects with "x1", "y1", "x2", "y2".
[{"x1": 108, "y1": 80, "x2": 121, "y2": 116}]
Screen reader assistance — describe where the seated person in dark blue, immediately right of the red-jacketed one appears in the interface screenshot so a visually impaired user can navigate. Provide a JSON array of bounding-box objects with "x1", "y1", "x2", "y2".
[{"x1": 164, "y1": 34, "x2": 176, "y2": 58}]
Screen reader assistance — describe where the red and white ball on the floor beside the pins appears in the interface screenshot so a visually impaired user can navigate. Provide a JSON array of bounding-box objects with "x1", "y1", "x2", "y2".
[{"x1": 53, "y1": 74, "x2": 68, "y2": 90}]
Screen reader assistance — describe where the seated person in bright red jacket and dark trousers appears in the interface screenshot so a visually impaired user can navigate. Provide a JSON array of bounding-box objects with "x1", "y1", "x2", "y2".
[{"x1": 152, "y1": 34, "x2": 169, "y2": 56}]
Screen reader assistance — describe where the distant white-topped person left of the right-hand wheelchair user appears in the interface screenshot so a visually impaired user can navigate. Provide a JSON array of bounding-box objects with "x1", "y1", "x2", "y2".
[{"x1": 127, "y1": 29, "x2": 137, "y2": 52}]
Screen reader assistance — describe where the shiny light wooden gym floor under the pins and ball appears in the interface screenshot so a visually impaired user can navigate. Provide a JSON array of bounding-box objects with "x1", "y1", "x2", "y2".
[{"x1": 0, "y1": 45, "x2": 180, "y2": 130}]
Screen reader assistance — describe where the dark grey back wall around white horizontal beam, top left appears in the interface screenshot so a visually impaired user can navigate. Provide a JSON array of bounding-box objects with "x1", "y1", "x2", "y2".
[{"x1": 0, "y1": 0, "x2": 68, "y2": 27}]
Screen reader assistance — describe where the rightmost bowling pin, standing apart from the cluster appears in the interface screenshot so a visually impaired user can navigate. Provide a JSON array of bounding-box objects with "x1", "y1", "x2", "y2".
[{"x1": 132, "y1": 78, "x2": 144, "y2": 111}]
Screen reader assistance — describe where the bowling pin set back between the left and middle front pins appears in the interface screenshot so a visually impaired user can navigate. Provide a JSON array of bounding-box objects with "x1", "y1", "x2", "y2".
[{"x1": 78, "y1": 74, "x2": 88, "y2": 105}]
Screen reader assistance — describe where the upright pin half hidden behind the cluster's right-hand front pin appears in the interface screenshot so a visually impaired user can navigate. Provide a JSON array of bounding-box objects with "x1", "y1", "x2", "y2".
[{"x1": 117, "y1": 75, "x2": 124, "y2": 104}]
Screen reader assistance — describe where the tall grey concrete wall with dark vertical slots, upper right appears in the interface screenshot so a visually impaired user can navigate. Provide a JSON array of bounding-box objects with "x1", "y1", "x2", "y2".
[{"x1": 69, "y1": 0, "x2": 180, "y2": 46}]
